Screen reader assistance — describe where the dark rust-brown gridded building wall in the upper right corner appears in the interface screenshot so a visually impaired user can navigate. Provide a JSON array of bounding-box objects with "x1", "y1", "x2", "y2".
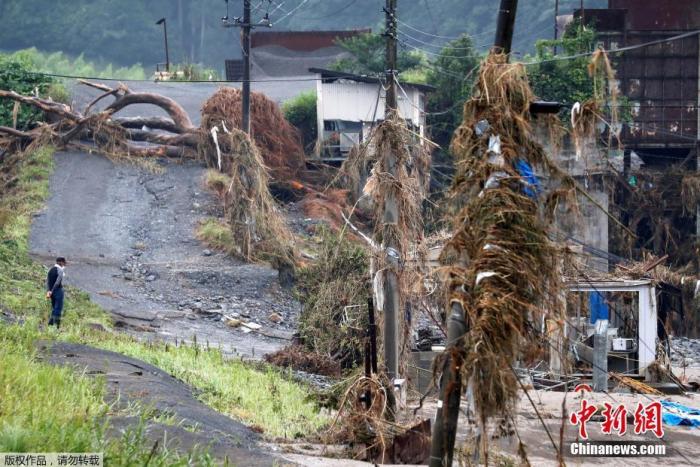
[{"x1": 575, "y1": 5, "x2": 700, "y2": 150}]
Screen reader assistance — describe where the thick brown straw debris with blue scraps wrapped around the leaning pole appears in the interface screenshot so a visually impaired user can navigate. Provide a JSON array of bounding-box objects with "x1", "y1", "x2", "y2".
[{"x1": 438, "y1": 54, "x2": 571, "y2": 436}]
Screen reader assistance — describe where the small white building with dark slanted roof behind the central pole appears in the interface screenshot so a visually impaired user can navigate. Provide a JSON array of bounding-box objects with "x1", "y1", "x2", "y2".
[{"x1": 309, "y1": 68, "x2": 435, "y2": 161}]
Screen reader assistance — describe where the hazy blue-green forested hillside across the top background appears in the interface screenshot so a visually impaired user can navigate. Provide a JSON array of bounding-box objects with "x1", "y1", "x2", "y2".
[{"x1": 0, "y1": 0, "x2": 607, "y2": 70}]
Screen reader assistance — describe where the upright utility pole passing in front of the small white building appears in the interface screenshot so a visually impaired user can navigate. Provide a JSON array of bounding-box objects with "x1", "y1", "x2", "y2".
[{"x1": 381, "y1": 0, "x2": 401, "y2": 387}]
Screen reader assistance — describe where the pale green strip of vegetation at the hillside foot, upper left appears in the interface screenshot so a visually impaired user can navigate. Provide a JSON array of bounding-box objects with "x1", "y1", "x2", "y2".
[{"x1": 11, "y1": 47, "x2": 146, "y2": 80}]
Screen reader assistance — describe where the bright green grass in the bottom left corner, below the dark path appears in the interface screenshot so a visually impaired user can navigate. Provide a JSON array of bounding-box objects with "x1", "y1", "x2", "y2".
[{"x1": 0, "y1": 326, "x2": 213, "y2": 467}]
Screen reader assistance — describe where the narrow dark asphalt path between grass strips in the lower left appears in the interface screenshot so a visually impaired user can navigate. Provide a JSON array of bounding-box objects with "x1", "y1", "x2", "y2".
[{"x1": 39, "y1": 342, "x2": 280, "y2": 466}]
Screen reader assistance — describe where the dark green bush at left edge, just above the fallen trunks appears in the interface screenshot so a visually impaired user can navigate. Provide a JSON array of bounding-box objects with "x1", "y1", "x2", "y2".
[{"x1": 0, "y1": 54, "x2": 53, "y2": 130}]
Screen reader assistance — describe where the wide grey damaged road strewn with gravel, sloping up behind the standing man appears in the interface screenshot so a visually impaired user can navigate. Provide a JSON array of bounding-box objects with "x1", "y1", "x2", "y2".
[{"x1": 30, "y1": 152, "x2": 299, "y2": 357}]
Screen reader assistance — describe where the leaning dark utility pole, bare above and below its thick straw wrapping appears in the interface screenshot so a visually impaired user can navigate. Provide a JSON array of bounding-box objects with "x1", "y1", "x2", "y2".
[{"x1": 430, "y1": 0, "x2": 518, "y2": 467}]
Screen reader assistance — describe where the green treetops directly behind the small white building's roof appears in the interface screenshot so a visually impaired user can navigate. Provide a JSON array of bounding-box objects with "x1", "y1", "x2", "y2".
[{"x1": 330, "y1": 33, "x2": 427, "y2": 76}]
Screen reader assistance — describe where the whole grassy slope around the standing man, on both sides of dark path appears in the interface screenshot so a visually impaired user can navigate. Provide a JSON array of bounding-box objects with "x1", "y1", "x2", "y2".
[{"x1": 0, "y1": 148, "x2": 327, "y2": 462}]
